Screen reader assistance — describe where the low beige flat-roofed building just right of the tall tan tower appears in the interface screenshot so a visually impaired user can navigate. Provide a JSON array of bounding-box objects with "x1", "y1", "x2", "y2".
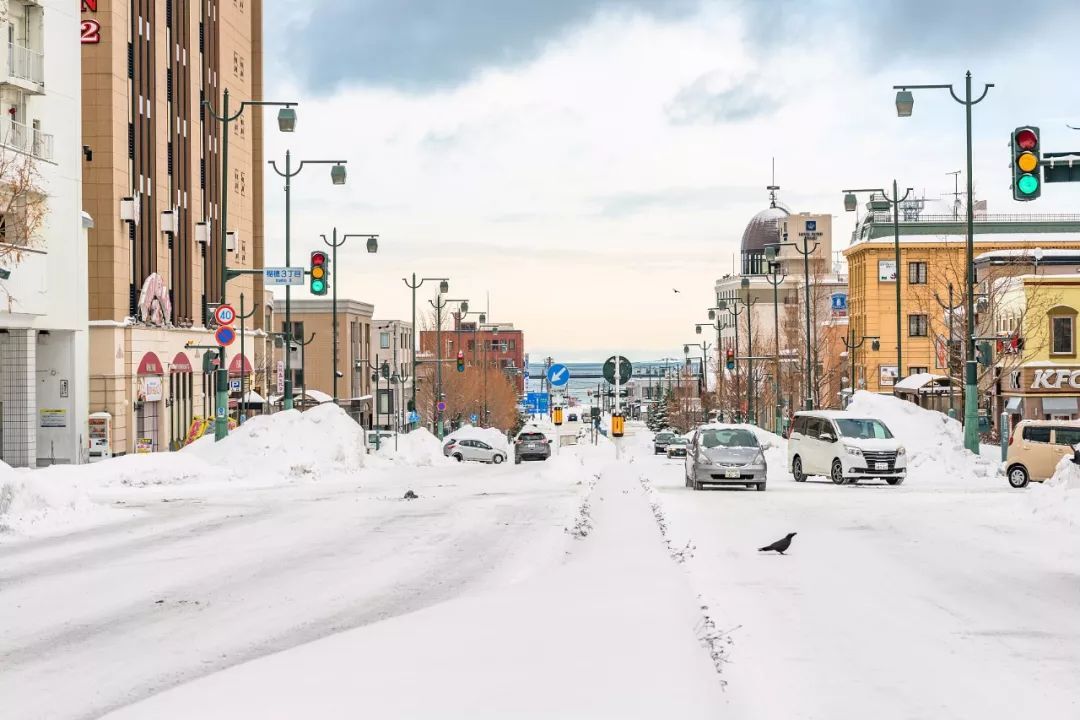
[{"x1": 274, "y1": 298, "x2": 375, "y2": 427}]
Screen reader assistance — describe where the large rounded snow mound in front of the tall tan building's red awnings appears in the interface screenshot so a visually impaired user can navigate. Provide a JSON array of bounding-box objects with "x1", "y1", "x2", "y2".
[{"x1": 179, "y1": 403, "x2": 365, "y2": 479}]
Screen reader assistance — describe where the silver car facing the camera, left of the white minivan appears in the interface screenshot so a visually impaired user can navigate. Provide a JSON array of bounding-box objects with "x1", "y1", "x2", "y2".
[{"x1": 686, "y1": 425, "x2": 769, "y2": 490}]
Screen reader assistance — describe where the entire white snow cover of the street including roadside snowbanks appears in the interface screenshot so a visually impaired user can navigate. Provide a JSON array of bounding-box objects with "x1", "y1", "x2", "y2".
[{"x1": 0, "y1": 393, "x2": 1080, "y2": 720}]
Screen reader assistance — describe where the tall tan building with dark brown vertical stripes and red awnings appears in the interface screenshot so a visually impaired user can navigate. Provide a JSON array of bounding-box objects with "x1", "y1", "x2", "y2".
[{"x1": 79, "y1": 0, "x2": 267, "y2": 453}]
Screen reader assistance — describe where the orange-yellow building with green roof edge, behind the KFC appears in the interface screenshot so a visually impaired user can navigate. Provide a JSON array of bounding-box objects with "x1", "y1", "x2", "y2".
[{"x1": 843, "y1": 199, "x2": 1080, "y2": 393}]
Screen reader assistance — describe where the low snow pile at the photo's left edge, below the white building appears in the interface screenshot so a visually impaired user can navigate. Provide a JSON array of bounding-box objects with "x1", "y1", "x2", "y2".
[{"x1": 0, "y1": 460, "x2": 112, "y2": 535}]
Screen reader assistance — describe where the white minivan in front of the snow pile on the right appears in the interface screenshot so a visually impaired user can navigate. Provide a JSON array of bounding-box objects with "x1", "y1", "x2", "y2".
[{"x1": 787, "y1": 410, "x2": 907, "y2": 485}]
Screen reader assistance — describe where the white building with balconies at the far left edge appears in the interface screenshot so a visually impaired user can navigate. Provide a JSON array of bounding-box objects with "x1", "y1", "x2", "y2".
[{"x1": 0, "y1": 0, "x2": 91, "y2": 467}]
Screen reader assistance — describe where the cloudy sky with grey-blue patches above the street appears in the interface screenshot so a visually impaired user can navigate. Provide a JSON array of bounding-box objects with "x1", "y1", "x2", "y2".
[{"x1": 265, "y1": 0, "x2": 1080, "y2": 361}]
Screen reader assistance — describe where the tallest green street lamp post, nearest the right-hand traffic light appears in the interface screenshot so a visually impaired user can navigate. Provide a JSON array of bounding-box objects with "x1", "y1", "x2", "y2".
[{"x1": 893, "y1": 70, "x2": 994, "y2": 453}]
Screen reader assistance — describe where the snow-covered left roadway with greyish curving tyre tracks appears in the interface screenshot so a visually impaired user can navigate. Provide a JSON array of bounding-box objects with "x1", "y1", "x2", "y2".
[{"x1": 0, "y1": 455, "x2": 582, "y2": 720}]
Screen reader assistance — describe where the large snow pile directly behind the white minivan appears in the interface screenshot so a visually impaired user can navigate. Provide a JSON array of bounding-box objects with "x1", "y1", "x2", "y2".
[{"x1": 848, "y1": 391, "x2": 998, "y2": 485}]
